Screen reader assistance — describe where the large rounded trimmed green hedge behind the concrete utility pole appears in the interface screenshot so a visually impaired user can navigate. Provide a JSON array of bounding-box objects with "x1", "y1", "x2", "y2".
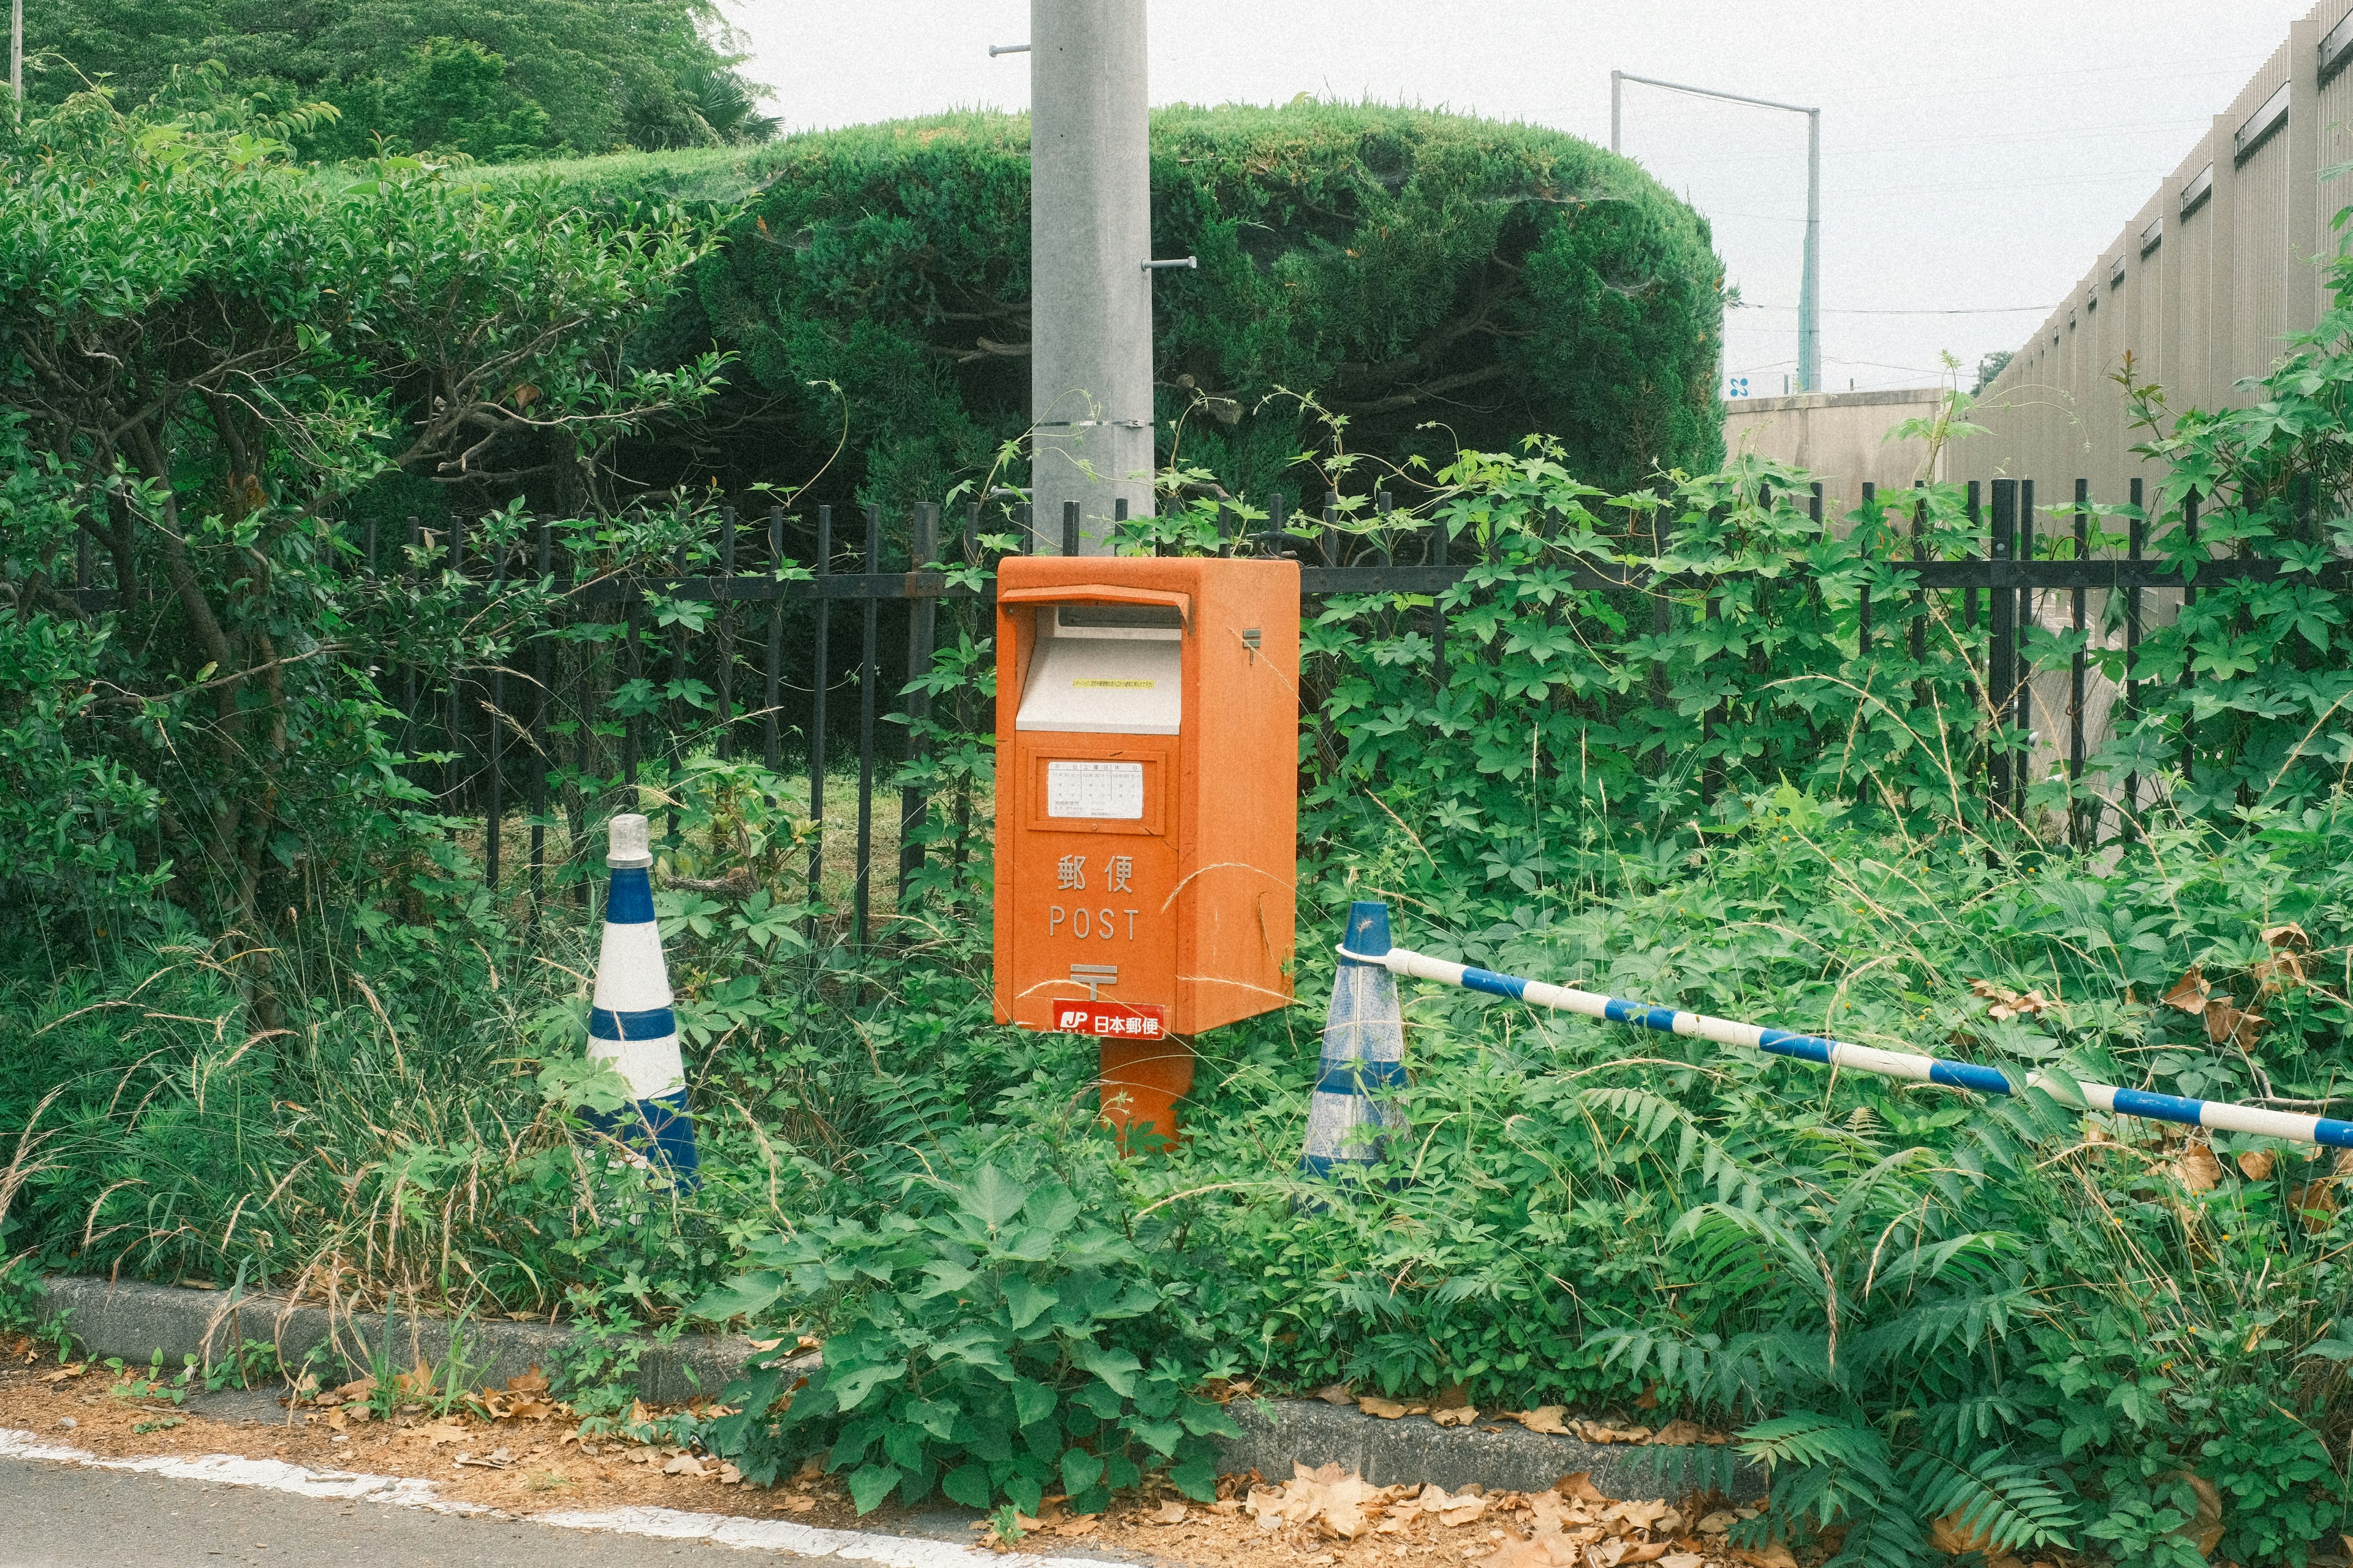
[{"x1": 558, "y1": 104, "x2": 1722, "y2": 501}]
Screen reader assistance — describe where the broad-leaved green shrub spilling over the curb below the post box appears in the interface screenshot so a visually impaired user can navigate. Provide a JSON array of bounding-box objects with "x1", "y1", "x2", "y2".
[{"x1": 697, "y1": 1137, "x2": 1240, "y2": 1514}]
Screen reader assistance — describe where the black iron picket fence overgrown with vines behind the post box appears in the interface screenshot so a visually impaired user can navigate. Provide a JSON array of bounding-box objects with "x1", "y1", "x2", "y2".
[{"x1": 64, "y1": 478, "x2": 2353, "y2": 927}]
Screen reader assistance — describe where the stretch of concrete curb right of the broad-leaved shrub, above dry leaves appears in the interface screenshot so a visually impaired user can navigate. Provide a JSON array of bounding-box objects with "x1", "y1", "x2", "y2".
[{"x1": 1219, "y1": 1398, "x2": 1765, "y2": 1500}]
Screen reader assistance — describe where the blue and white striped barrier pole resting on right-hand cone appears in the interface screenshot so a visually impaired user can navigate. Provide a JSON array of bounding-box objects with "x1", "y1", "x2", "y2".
[{"x1": 1339, "y1": 904, "x2": 2353, "y2": 1149}]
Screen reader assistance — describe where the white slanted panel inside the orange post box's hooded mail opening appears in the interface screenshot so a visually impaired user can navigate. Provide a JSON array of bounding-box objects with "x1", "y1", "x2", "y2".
[{"x1": 1014, "y1": 605, "x2": 1184, "y2": 735}]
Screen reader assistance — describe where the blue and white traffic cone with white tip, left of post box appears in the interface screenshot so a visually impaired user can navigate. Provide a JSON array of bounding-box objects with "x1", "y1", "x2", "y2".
[{"x1": 586, "y1": 814, "x2": 696, "y2": 1187}]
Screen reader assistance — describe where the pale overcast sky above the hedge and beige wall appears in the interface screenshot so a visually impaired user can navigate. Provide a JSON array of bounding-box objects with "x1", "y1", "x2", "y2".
[{"x1": 727, "y1": 0, "x2": 2311, "y2": 393}]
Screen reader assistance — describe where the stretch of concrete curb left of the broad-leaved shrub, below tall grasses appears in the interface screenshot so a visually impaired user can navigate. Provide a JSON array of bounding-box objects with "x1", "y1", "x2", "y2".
[{"x1": 40, "y1": 1274, "x2": 753, "y2": 1406}]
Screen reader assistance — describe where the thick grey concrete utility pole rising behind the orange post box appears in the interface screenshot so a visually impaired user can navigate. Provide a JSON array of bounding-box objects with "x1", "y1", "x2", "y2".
[{"x1": 1031, "y1": 0, "x2": 1153, "y2": 556}]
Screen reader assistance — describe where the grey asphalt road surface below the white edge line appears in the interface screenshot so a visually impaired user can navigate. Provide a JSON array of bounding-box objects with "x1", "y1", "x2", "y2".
[{"x1": 0, "y1": 1460, "x2": 809, "y2": 1568}]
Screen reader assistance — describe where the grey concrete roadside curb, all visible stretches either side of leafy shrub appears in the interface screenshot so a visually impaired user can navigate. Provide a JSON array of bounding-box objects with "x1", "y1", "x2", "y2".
[{"x1": 40, "y1": 1274, "x2": 1765, "y2": 1500}]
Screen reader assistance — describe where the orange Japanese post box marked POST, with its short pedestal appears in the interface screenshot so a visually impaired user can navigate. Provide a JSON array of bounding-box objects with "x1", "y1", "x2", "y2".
[{"x1": 995, "y1": 556, "x2": 1299, "y2": 1137}]
